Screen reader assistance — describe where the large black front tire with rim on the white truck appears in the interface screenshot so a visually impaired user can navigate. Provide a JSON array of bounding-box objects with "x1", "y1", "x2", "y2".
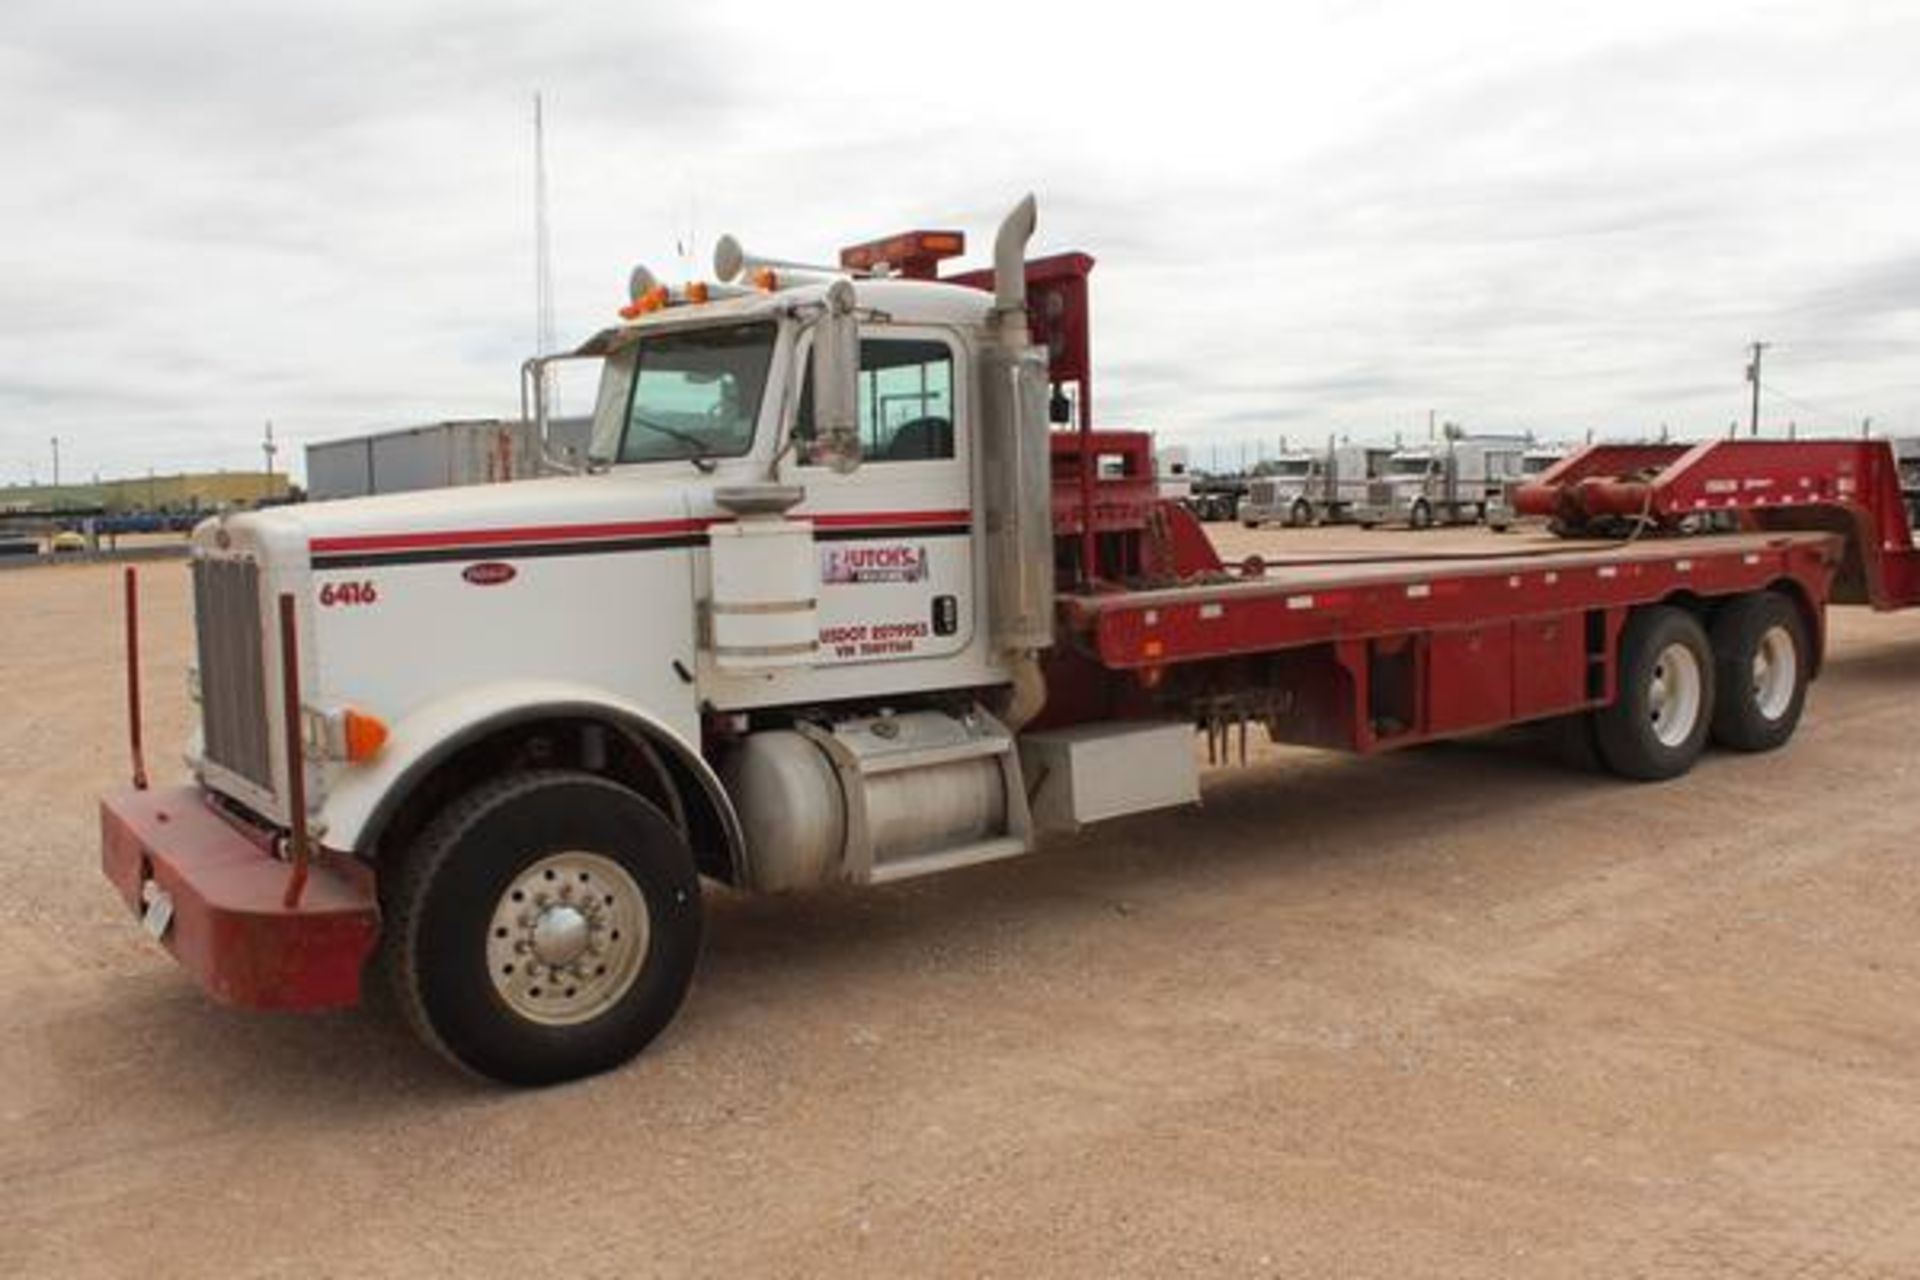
[{"x1": 388, "y1": 770, "x2": 701, "y2": 1084}]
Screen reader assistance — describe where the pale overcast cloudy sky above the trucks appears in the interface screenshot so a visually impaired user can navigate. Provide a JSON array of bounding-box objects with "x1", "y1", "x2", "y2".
[{"x1": 0, "y1": 0, "x2": 1920, "y2": 484}]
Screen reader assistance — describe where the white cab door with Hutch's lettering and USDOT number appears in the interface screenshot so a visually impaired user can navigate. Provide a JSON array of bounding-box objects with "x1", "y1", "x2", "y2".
[{"x1": 793, "y1": 326, "x2": 975, "y2": 666}]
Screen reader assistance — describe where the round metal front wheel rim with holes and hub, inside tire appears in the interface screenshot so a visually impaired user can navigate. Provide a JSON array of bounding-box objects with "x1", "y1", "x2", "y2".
[{"x1": 486, "y1": 852, "x2": 653, "y2": 1027}]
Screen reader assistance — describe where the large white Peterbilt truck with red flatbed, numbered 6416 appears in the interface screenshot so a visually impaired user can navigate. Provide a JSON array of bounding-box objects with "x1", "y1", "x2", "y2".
[{"x1": 102, "y1": 198, "x2": 1873, "y2": 1082}]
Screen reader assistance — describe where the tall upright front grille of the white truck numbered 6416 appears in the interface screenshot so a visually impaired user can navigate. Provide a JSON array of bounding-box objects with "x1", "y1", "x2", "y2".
[{"x1": 194, "y1": 560, "x2": 273, "y2": 791}]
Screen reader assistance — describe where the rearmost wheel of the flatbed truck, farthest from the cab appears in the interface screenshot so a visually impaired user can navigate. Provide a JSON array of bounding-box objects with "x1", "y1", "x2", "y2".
[{"x1": 1713, "y1": 591, "x2": 1812, "y2": 750}]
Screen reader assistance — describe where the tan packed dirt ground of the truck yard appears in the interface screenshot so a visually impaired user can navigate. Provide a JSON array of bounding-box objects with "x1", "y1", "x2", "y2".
[{"x1": 0, "y1": 530, "x2": 1920, "y2": 1278}]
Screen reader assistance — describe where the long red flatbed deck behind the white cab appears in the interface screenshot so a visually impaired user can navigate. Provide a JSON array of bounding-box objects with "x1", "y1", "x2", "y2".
[{"x1": 1060, "y1": 532, "x2": 1843, "y2": 752}]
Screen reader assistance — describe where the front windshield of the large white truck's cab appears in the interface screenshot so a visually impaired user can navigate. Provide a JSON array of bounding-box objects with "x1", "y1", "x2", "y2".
[{"x1": 595, "y1": 320, "x2": 776, "y2": 462}]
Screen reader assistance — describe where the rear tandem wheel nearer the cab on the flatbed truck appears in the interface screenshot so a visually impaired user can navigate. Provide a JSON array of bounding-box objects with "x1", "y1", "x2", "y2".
[{"x1": 1594, "y1": 604, "x2": 1715, "y2": 781}]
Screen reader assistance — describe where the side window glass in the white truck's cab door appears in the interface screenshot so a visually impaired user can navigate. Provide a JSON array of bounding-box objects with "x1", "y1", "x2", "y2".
[{"x1": 793, "y1": 338, "x2": 954, "y2": 466}]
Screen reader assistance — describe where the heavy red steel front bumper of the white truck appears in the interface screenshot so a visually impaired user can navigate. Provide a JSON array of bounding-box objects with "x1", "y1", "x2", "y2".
[{"x1": 100, "y1": 787, "x2": 380, "y2": 1009}]
